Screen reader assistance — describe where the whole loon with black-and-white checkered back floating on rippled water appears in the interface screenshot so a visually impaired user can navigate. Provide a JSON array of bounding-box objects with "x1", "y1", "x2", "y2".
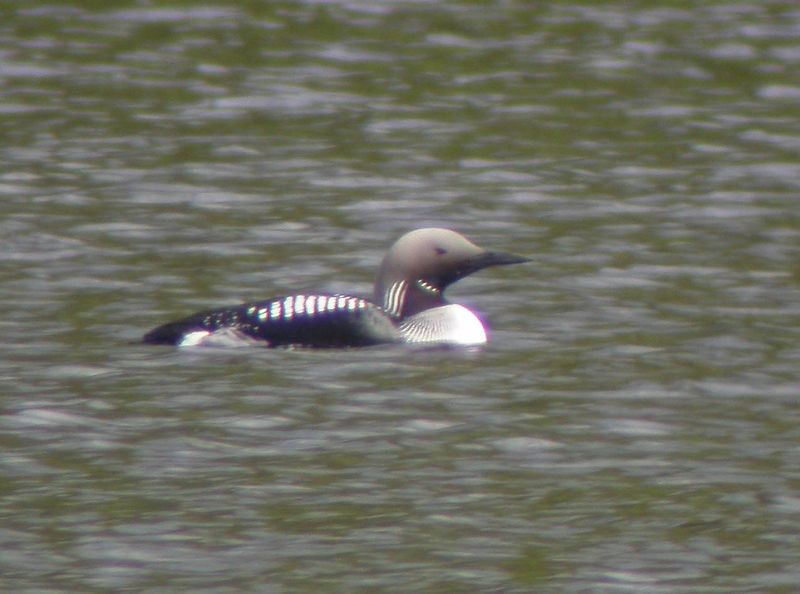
[{"x1": 142, "y1": 228, "x2": 529, "y2": 348}]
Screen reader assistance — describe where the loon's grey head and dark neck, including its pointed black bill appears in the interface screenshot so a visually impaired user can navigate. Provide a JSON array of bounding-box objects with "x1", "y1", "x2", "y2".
[{"x1": 375, "y1": 227, "x2": 529, "y2": 320}]
